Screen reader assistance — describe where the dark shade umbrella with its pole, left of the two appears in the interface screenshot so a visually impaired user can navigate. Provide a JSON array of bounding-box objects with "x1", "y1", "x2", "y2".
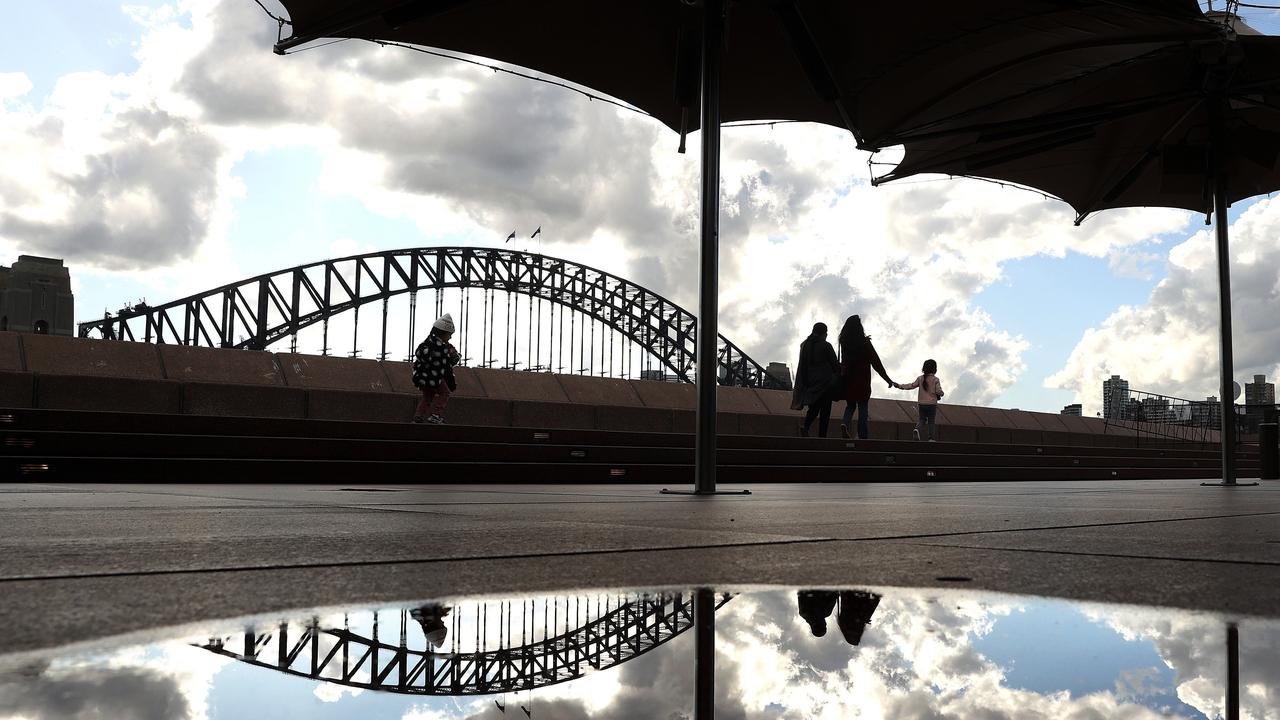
[{"x1": 267, "y1": 0, "x2": 870, "y2": 495}]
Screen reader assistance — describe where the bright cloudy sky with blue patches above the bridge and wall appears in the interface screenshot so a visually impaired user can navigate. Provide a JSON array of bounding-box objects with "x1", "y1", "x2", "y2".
[{"x1": 0, "y1": 0, "x2": 1280, "y2": 414}]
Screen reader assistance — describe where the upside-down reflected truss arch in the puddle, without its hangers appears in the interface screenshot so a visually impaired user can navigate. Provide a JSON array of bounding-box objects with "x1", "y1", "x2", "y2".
[{"x1": 198, "y1": 592, "x2": 732, "y2": 696}]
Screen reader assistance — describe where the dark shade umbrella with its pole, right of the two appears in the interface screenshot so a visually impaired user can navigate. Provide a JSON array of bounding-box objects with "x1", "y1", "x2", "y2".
[{"x1": 855, "y1": 0, "x2": 1280, "y2": 484}]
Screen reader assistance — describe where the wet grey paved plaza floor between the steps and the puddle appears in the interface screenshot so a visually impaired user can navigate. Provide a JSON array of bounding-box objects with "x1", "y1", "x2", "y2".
[{"x1": 0, "y1": 480, "x2": 1280, "y2": 653}]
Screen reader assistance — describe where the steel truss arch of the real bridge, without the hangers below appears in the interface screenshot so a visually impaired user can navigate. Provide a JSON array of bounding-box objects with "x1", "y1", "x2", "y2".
[{"x1": 79, "y1": 247, "x2": 783, "y2": 388}]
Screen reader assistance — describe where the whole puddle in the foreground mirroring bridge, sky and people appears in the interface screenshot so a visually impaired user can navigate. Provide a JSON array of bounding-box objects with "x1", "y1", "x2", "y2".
[{"x1": 0, "y1": 589, "x2": 1280, "y2": 720}]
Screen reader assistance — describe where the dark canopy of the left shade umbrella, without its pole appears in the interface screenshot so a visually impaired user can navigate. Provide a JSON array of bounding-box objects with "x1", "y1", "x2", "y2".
[{"x1": 276, "y1": 0, "x2": 856, "y2": 140}]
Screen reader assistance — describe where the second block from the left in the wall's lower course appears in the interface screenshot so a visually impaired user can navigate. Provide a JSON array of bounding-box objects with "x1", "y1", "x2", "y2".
[{"x1": 35, "y1": 371, "x2": 182, "y2": 415}]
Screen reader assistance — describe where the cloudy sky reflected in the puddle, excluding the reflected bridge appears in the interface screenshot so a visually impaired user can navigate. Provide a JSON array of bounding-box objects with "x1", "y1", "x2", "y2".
[{"x1": 0, "y1": 589, "x2": 1280, "y2": 720}]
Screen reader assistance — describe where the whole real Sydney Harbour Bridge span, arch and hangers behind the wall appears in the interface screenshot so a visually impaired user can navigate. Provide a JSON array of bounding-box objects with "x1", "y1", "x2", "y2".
[{"x1": 79, "y1": 247, "x2": 788, "y2": 388}]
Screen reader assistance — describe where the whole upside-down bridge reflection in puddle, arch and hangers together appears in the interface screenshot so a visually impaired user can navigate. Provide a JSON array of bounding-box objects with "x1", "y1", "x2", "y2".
[{"x1": 200, "y1": 592, "x2": 732, "y2": 696}]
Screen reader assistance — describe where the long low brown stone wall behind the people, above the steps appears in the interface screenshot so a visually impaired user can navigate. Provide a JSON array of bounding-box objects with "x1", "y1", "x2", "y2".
[{"x1": 0, "y1": 332, "x2": 1198, "y2": 446}]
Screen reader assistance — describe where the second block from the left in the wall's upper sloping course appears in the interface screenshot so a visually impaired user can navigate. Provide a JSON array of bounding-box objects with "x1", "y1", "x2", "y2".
[{"x1": 22, "y1": 334, "x2": 164, "y2": 380}]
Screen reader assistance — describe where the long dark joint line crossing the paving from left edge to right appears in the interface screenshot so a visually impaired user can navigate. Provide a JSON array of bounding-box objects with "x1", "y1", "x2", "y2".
[{"x1": 0, "y1": 504, "x2": 1280, "y2": 584}]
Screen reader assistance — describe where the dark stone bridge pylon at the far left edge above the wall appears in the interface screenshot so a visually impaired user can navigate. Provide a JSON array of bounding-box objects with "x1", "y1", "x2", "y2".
[{"x1": 0, "y1": 255, "x2": 76, "y2": 336}]
